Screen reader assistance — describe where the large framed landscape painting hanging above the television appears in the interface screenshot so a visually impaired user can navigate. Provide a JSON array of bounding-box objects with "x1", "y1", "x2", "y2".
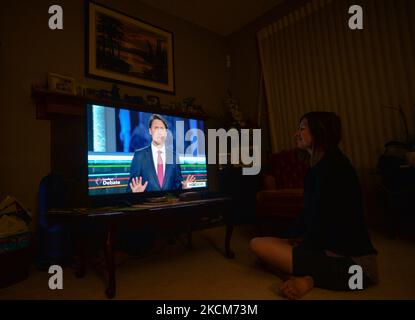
[{"x1": 86, "y1": 1, "x2": 175, "y2": 94}]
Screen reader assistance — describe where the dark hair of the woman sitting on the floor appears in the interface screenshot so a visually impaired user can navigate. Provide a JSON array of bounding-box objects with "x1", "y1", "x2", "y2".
[{"x1": 300, "y1": 111, "x2": 342, "y2": 151}]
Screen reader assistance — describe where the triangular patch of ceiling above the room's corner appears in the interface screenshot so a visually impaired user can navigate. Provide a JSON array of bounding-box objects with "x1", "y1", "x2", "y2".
[{"x1": 141, "y1": 0, "x2": 284, "y2": 36}]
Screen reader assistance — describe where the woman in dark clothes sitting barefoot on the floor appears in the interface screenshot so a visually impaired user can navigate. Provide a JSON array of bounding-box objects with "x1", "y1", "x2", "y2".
[{"x1": 251, "y1": 112, "x2": 378, "y2": 299}]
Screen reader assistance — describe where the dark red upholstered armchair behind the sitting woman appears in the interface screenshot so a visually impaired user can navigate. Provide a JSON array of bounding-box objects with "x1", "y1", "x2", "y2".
[{"x1": 256, "y1": 149, "x2": 308, "y2": 232}]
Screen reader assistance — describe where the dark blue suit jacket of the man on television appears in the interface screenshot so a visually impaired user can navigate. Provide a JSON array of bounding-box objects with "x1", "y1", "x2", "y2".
[{"x1": 127, "y1": 146, "x2": 183, "y2": 192}]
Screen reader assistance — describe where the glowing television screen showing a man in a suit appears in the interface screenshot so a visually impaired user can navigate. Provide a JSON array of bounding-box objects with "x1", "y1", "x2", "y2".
[{"x1": 87, "y1": 104, "x2": 208, "y2": 196}]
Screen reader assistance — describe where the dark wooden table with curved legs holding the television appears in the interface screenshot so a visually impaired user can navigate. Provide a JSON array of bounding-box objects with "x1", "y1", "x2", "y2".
[{"x1": 47, "y1": 197, "x2": 234, "y2": 299}]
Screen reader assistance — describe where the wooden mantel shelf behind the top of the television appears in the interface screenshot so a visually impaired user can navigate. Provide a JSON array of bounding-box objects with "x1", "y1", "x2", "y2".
[{"x1": 32, "y1": 88, "x2": 209, "y2": 120}]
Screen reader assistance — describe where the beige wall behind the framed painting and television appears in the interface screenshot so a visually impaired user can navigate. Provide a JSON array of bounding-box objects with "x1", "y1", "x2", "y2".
[{"x1": 0, "y1": 0, "x2": 226, "y2": 220}]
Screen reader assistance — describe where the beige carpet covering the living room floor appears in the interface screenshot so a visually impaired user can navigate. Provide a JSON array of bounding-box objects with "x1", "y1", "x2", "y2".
[{"x1": 0, "y1": 226, "x2": 415, "y2": 299}]
